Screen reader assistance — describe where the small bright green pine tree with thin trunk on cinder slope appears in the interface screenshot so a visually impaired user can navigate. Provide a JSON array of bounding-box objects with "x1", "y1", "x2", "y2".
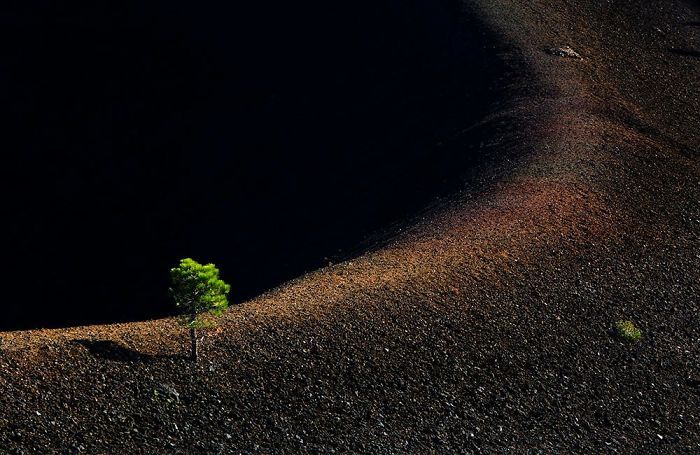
[{"x1": 170, "y1": 258, "x2": 231, "y2": 361}]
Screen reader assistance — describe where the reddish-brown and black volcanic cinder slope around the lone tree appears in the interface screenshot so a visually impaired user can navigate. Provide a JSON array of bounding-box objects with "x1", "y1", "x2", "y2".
[{"x1": 0, "y1": 0, "x2": 700, "y2": 453}]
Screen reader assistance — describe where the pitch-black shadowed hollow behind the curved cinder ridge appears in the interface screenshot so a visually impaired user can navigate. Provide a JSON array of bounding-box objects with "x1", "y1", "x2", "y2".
[{"x1": 0, "y1": 0, "x2": 498, "y2": 329}]
